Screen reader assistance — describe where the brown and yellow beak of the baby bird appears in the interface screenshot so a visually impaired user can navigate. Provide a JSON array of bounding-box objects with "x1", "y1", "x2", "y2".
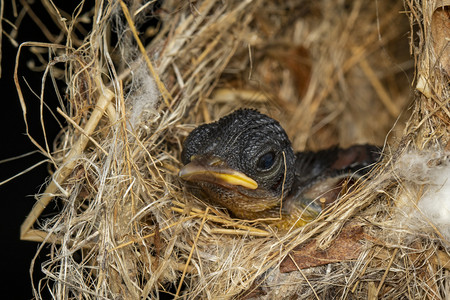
[{"x1": 178, "y1": 156, "x2": 258, "y2": 190}]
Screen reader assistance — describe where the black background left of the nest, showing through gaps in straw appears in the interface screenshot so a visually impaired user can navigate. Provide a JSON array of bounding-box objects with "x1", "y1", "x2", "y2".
[{"x1": 0, "y1": 0, "x2": 160, "y2": 299}]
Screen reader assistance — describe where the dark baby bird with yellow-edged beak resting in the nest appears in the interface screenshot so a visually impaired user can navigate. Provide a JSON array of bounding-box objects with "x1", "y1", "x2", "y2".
[{"x1": 179, "y1": 109, "x2": 380, "y2": 227}]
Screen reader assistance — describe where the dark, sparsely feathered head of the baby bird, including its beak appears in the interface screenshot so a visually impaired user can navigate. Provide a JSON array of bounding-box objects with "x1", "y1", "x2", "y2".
[{"x1": 179, "y1": 109, "x2": 295, "y2": 218}]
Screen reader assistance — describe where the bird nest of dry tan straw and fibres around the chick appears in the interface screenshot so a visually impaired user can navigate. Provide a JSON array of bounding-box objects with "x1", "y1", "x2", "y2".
[{"x1": 15, "y1": 0, "x2": 450, "y2": 299}]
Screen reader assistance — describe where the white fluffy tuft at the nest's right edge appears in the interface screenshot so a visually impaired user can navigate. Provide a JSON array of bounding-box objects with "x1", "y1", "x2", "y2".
[{"x1": 395, "y1": 151, "x2": 450, "y2": 241}]
